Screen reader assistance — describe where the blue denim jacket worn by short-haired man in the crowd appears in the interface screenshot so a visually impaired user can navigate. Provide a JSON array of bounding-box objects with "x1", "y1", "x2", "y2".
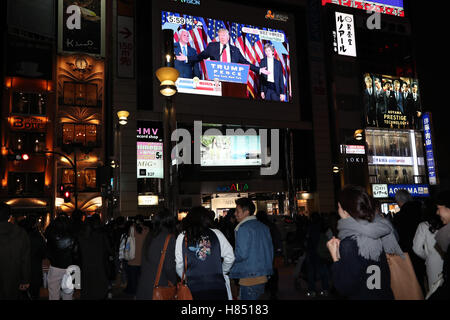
[{"x1": 230, "y1": 216, "x2": 273, "y2": 279}]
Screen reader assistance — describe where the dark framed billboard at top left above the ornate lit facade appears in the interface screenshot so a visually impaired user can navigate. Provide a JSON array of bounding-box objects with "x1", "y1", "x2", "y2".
[{"x1": 58, "y1": 0, "x2": 106, "y2": 57}]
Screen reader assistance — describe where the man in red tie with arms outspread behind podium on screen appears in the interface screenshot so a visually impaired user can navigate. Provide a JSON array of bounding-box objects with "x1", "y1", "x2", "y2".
[{"x1": 177, "y1": 29, "x2": 269, "y2": 75}]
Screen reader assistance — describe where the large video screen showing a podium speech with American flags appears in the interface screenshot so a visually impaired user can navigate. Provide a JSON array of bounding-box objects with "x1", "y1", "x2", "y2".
[{"x1": 161, "y1": 11, "x2": 292, "y2": 102}]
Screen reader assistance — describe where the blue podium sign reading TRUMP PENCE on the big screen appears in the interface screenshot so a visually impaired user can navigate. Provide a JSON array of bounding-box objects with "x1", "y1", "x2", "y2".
[{"x1": 205, "y1": 60, "x2": 250, "y2": 84}]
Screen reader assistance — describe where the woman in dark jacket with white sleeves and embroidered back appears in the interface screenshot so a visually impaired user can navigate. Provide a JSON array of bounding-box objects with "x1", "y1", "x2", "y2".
[{"x1": 175, "y1": 207, "x2": 234, "y2": 300}]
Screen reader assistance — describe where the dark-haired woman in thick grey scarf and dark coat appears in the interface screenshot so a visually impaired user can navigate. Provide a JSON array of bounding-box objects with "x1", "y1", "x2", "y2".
[{"x1": 327, "y1": 186, "x2": 403, "y2": 300}]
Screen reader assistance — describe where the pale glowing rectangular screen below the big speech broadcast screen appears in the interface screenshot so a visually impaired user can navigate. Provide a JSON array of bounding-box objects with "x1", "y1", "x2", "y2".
[{"x1": 200, "y1": 135, "x2": 262, "y2": 166}]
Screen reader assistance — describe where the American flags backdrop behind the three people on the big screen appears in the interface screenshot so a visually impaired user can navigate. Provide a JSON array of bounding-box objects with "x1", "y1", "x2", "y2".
[{"x1": 161, "y1": 11, "x2": 292, "y2": 99}]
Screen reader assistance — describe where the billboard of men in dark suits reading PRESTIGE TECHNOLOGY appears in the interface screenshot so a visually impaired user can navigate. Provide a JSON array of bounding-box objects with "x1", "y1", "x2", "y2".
[{"x1": 363, "y1": 73, "x2": 422, "y2": 130}]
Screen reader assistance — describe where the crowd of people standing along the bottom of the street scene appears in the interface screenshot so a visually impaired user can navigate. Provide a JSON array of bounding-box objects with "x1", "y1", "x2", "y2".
[{"x1": 0, "y1": 186, "x2": 450, "y2": 300}]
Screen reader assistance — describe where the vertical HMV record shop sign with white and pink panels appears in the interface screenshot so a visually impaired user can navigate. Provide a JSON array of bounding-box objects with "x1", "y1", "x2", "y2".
[{"x1": 136, "y1": 121, "x2": 164, "y2": 179}]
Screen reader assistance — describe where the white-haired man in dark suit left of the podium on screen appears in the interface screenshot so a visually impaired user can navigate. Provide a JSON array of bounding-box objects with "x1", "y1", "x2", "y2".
[{"x1": 173, "y1": 29, "x2": 202, "y2": 79}]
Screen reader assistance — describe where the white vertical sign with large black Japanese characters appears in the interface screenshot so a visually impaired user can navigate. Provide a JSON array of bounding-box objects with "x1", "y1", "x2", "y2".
[{"x1": 335, "y1": 12, "x2": 356, "y2": 57}]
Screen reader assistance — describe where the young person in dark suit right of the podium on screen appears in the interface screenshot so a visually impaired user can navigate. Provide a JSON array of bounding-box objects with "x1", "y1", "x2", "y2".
[{"x1": 260, "y1": 43, "x2": 285, "y2": 101}]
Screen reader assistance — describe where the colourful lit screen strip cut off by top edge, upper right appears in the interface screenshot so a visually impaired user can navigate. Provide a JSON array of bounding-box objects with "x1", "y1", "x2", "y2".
[{"x1": 322, "y1": 0, "x2": 405, "y2": 17}]
